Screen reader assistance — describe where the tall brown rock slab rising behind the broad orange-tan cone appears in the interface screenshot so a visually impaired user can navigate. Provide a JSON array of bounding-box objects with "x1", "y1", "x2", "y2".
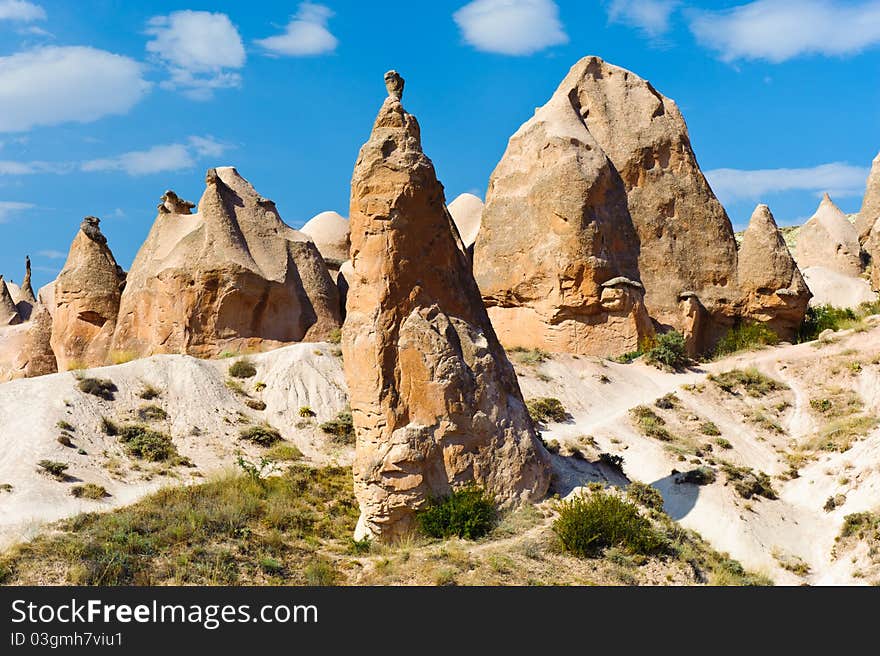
[{"x1": 557, "y1": 57, "x2": 737, "y2": 350}]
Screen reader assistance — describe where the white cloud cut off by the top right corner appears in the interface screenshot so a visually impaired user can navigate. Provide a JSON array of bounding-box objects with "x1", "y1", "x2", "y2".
[{"x1": 690, "y1": 0, "x2": 880, "y2": 63}]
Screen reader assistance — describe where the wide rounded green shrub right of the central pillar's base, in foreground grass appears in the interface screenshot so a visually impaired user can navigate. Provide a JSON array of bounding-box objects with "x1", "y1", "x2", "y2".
[{"x1": 553, "y1": 492, "x2": 666, "y2": 558}]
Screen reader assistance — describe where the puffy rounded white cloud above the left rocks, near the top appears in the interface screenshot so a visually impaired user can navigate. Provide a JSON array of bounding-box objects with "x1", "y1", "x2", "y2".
[{"x1": 147, "y1": 10, "x2": 247, "y2": 100}]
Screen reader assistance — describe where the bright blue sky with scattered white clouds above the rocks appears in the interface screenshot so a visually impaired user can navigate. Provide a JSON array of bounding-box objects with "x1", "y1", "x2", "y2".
[{"x1": 0, "y1": 0, "x2": 880, "y2": 285}]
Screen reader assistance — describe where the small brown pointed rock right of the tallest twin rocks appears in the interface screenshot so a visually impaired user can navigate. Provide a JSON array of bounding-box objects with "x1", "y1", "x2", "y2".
[{"x1": 737, "y1": 205, "x2": 812, "y2": 340}]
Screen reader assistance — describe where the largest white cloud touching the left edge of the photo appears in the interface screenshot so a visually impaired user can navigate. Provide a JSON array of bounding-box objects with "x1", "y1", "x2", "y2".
[{"x1": 0, "y1": 46, "x2": 150, "y2": 132}]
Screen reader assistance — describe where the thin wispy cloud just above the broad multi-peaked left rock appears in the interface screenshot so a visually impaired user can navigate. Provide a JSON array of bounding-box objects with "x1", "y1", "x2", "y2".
[{"x1": 80, "y1": 137, "x2": 227, "y2": 176}]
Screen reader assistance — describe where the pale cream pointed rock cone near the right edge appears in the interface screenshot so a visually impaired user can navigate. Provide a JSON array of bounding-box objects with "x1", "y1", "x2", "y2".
[{"x1": 794, "y1": 194, "x2": 864, "y2": 277}]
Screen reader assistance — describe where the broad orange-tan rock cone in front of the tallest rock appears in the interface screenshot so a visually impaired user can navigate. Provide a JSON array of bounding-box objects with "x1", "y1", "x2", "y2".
[{"x1": 474, "y1": 62, "x2": 653, "y2": 355}]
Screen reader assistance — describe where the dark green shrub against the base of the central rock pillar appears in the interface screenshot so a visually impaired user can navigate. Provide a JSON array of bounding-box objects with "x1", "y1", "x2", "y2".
[{"x1": 416, "y1": 484, "x2": 497, "y2": 540}]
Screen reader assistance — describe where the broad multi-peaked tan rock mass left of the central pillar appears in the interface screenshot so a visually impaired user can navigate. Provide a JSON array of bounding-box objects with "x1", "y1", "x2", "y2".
[{"x1": 113, "y1": 172, "x2": 340, "y2": 357}]
